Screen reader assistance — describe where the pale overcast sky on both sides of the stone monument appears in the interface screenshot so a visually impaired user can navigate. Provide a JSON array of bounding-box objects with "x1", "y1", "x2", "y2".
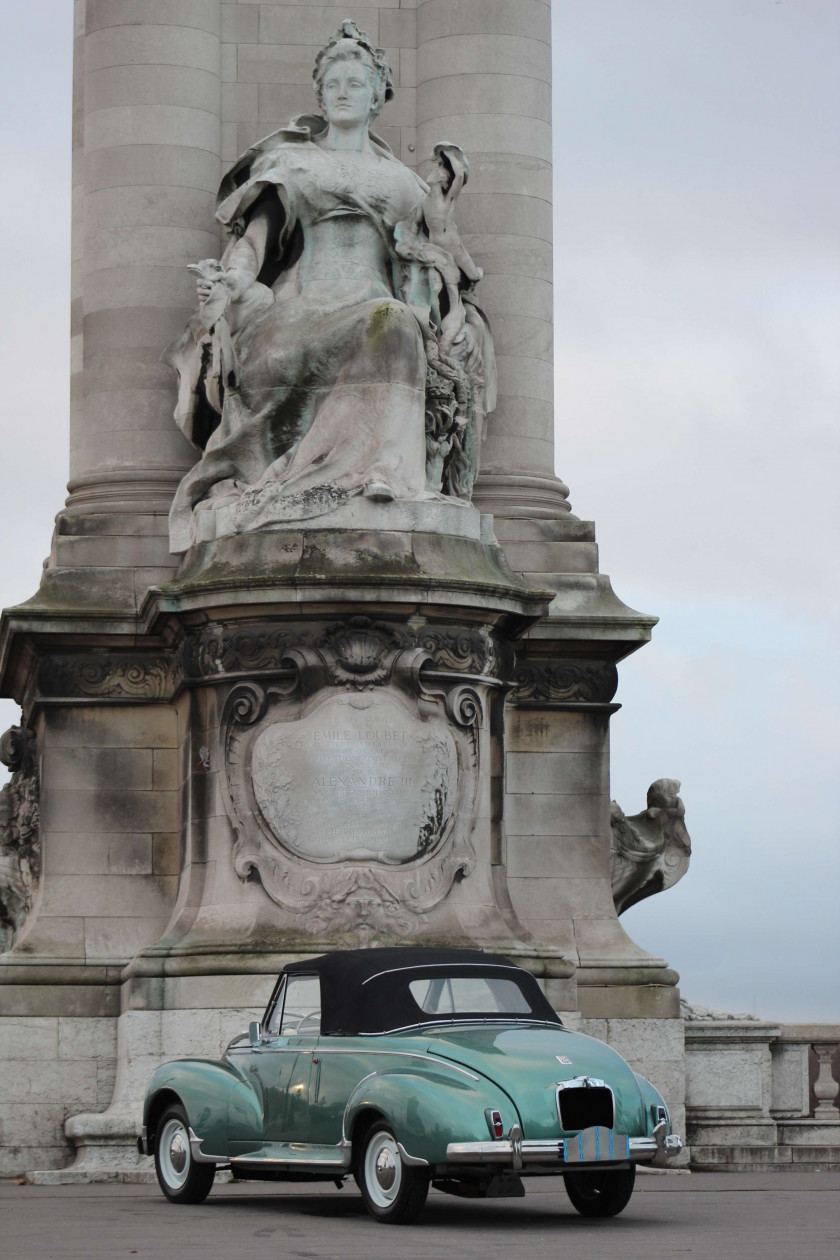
[{"x1": 0, "y1": 0, "x2": 840, "y2": 1022}]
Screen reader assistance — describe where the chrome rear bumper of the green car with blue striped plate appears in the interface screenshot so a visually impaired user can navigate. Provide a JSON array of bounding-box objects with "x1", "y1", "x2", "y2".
[{"x1": 446, "y1": 1121, "x2": 683, "y2": 1169}]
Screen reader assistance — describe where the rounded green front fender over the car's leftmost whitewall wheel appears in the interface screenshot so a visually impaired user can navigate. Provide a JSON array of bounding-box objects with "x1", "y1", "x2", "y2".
[{"x1": 144, "y1": 1058, "x2": 242, "y2": 1157}]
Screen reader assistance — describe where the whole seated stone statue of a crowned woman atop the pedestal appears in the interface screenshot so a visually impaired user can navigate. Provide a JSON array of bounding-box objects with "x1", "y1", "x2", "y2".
[{"x1": 164, "y1": 20, "x2": 495, "y2": 552}]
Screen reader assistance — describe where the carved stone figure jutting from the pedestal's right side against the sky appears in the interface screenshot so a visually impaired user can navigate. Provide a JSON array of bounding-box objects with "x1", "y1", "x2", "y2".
[{"x1": 610, "y1": 779, "x2": 691, "y2": 915}]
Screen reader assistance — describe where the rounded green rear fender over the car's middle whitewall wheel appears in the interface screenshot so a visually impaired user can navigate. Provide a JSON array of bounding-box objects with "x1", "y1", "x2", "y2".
[{"x1": 344, "y1": 1070, "x2": 521, "y2": 1164}]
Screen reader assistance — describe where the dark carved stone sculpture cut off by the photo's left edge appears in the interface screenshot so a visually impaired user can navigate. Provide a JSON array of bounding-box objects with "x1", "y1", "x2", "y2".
[{"x1": 0, "y1": 726, "x2": 40, "y2": 951}]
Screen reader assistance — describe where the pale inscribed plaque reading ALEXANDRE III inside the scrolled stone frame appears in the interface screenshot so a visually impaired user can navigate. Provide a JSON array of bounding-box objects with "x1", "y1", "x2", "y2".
[{"x1": 251, "y1": 692, "x2": 457, "y2": 864}]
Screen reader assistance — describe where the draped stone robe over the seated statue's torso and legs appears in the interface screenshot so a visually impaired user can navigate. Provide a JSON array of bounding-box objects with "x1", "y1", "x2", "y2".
[{"x1": 170, "y1": 120, "x2": 427, "y2": 549}]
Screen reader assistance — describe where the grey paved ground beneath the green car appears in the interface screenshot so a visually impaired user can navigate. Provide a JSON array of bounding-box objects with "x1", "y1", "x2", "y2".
[{"x1": 0, "y1": 1173, "x2": 840, "y2": 1260}]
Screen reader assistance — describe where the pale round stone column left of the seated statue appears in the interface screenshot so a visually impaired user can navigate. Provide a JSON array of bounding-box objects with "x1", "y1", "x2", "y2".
[{"x1": 68, "y1": 0, "x2": 220, "y2": 521}]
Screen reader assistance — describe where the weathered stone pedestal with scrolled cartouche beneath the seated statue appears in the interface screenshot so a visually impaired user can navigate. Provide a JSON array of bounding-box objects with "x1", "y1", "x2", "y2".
[{"x1": 0, "y1": 505, "x2": 679, "y2": 1177}]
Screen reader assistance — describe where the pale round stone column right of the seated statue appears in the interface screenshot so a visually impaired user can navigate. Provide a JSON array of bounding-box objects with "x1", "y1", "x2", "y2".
[{"x1": 417, "y1": 0, "x2": 569, "y2": 519}]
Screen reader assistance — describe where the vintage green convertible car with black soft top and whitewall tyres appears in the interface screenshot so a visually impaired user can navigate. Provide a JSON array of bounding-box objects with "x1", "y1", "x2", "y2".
[{"x1": 139, "y1": 948, "x2": 681, "y2": 1223}]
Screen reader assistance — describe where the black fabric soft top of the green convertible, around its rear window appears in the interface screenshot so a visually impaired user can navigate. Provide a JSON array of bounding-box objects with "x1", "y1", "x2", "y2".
[{"x1": 283, "y1": 946, "x2": 560, "y2": 1036}]
